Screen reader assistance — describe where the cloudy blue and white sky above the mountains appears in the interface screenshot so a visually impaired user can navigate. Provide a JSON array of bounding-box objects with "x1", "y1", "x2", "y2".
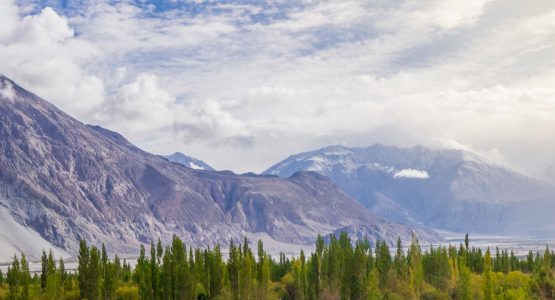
[{"x1": 0, "y1": 0, "x2": 555, "y2": 177}]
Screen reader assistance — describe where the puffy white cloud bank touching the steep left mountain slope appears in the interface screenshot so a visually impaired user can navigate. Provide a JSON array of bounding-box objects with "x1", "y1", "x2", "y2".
[{"x1": 0, "y1": 1, "x2": 104, "y2": 120}]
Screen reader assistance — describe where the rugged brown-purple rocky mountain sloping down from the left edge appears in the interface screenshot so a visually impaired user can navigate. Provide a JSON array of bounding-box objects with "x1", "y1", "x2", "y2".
[{"x1": 0, "y1": 77, "x2": 438, "y2": 256}]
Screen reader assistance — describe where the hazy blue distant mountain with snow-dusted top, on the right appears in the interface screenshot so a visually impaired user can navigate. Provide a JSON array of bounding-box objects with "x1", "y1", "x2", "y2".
[{"x1": 264, "y1": 144, "x2": 555, "y2": 235}]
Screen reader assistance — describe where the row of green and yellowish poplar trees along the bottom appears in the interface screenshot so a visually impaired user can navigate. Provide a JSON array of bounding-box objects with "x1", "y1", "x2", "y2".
[{"x1": 0, "y1": 233, "x2": 555, "y2": 300}]
